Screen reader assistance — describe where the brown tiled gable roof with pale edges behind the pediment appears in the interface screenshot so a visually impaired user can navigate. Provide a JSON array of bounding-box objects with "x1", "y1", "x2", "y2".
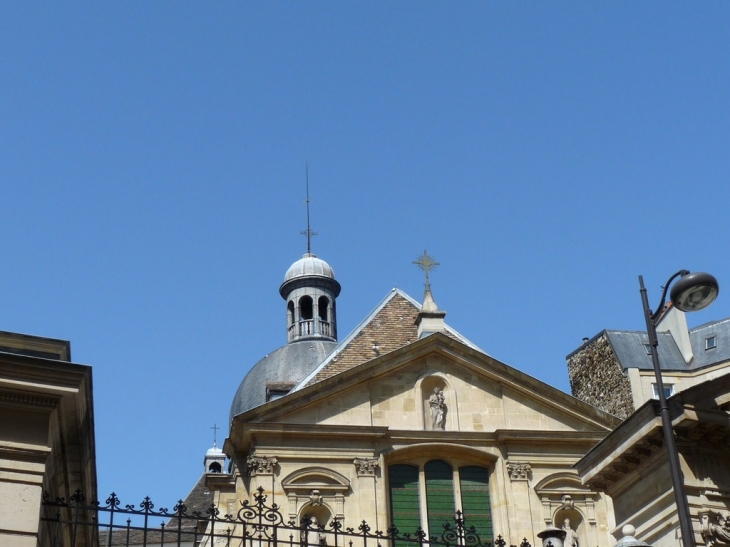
[{"x1": 292, "y1": 288, "x2": 484, "y2": 391}]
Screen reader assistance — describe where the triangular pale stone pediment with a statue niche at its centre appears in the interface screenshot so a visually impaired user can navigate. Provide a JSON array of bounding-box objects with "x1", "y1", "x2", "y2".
[{"x1": 235, "y1": 333, "x2": 618, "y2": 433}]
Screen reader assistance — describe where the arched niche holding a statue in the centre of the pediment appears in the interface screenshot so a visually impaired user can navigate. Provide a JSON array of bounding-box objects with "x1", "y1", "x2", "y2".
[{"x1": 413, "y1": 372, "x2": 452, "y2": 431}]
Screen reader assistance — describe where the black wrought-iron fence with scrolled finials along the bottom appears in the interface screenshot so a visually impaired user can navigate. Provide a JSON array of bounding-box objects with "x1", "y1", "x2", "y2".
[{"x1": 39, "y1": 488, "x2": 532, "y2": 547}]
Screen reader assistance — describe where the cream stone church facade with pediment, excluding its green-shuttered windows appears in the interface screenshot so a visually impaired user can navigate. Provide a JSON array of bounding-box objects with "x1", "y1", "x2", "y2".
[{"x1": 218, "y1": 333, "x2": 618, "y2": 547}]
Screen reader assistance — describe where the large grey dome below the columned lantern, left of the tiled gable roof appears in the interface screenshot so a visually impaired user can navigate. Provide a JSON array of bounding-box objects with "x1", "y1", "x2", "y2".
[{"x1": 230, "y1": 340, "x2": 337, "y2": 420}]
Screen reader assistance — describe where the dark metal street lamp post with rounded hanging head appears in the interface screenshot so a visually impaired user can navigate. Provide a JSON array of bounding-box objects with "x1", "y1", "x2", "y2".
[{"x1": 639, "y1": 270, "x2": 720, "y2": 547}]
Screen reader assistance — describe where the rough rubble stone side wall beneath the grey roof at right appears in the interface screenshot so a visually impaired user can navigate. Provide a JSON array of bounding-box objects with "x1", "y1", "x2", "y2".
[{"x1": 568, "y1": 332, "x2": 634, "y2": 419}]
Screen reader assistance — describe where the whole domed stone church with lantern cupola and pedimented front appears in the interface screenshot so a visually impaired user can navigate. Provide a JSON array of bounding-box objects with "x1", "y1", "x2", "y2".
[{"x1": 207, "y1": 253, "x2": 619, "y2": 547}]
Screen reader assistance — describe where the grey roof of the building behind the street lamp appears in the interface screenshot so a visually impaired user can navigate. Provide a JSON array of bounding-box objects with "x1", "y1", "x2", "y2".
[{"x1": 568, "y1": 318, "x2": 730, "y2": 372}]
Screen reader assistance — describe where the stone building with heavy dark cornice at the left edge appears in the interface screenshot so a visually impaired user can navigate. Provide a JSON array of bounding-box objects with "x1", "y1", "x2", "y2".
[{"x1": 0, "y1": 332, "x2": 96, "y2": 547}]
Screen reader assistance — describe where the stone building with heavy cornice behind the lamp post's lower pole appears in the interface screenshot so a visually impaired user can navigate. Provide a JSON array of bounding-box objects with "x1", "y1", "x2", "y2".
[{"x1": 576, "y1": 375, "x2": 730, "y2": 547}]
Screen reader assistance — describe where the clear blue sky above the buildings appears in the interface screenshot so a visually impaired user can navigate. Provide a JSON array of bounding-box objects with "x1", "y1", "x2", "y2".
[{"x1": 0, "y1": 1, "x2": 730, "y2": 507}]
